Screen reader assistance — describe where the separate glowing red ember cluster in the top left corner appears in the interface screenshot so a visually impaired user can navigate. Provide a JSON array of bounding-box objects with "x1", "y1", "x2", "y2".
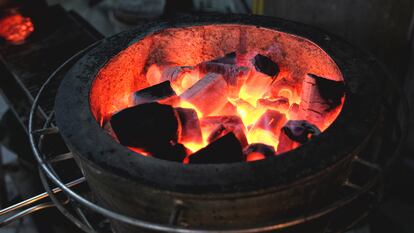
[{"x1": 0, "y1": 13, "x2": 34, "y2": 44}]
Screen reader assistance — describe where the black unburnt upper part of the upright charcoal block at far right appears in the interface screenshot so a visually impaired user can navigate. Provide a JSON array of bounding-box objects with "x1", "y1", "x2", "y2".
[{"x1": 308, "y1": 74, "x2": 345, "y2": 111}]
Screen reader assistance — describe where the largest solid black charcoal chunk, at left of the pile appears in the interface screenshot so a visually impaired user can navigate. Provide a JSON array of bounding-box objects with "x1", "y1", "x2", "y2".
[{"x1": 110, "y1": 103, "x2": 178, "y2": 150}]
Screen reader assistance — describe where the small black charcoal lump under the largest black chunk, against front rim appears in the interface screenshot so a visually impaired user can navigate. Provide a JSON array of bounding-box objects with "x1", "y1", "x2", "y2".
[{"x1": 151, "y1": 143, "x2": 188, "y2": 163}]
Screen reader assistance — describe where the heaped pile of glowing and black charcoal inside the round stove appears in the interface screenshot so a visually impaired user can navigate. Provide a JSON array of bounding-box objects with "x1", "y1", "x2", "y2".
[{"x1": 103, "y1": 52, "x2": 344, "y2": 164}]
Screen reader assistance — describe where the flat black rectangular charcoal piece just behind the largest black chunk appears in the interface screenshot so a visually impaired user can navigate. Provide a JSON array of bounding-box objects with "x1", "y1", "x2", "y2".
[{"x1": 134, "y1": 81, "x2": 176, "y2": 105}]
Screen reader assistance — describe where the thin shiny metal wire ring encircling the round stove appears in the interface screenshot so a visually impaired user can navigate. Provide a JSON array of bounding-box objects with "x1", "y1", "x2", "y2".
[{"x1": 21, "y1": 37, "x2": 404, "y2": 233}]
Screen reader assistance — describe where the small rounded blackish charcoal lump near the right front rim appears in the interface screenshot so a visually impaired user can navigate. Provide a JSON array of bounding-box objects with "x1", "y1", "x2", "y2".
[{"x1": 282, "y1": 120, "x2": 321, "y2": 144}]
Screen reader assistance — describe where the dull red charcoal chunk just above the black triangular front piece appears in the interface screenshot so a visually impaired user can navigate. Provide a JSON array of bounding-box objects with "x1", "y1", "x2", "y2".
[{"x1": 201, "y1": 116, "x2": 248, "y2": 147}]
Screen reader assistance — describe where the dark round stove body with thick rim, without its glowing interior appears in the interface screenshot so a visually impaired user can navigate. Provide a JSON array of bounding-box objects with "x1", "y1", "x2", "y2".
[{"x1": 55, "y1": 15, "x2": 385, "y2": 232}]
